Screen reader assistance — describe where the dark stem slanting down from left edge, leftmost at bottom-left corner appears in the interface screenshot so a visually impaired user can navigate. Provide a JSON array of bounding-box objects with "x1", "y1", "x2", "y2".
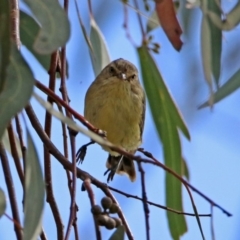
[{"x1": 0, "y1": 143, "x2": 22, "y2": 240}]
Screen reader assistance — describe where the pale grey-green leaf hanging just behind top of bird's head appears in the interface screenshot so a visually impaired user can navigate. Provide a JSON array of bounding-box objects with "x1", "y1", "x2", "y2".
[{"x1": 90, "y1": 18, "x2": 110, "y2": 76}]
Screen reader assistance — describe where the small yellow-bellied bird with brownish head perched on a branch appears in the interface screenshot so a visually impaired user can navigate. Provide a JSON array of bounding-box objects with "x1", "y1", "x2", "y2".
[{"x1": 84, "y1": 58, "x2": 146, "y2": 182}]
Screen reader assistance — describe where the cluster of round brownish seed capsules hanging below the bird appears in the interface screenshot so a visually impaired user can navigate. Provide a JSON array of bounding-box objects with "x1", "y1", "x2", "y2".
[{"x1": 91, "y1": 197, "x2": 122, "y2": 230}]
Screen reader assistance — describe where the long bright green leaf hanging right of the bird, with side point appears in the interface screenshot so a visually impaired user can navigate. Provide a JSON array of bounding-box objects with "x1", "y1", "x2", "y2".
[{"x1": 138, "y1": 47, "x2": 190, "y2": 239}]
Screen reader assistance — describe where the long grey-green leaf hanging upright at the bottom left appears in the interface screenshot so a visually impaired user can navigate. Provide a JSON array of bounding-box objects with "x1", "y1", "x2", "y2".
[{"x1": 23, "y1": 130, "x2": 45, "y2": 240}]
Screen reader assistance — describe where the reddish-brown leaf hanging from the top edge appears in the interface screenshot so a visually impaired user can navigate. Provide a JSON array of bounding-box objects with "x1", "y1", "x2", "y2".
[{"x1": 155, "y1": 0, "x2": 182, "y2": 51}]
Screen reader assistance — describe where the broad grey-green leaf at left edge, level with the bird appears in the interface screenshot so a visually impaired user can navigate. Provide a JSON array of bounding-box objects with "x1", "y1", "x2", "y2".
[{"x1": 0, "y1": 46, "x2": 34, "y2": 139}]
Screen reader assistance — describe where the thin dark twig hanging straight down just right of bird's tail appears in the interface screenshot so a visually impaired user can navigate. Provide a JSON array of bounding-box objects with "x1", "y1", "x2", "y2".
[{"x1": 138, "y1": 162, "x2": 150, "y2": 240}]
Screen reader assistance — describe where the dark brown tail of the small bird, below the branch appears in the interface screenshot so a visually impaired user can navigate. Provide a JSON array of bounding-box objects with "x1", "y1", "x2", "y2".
[{"x1": 106, "y1": 154, "x2": 136, "y2": 182}]
